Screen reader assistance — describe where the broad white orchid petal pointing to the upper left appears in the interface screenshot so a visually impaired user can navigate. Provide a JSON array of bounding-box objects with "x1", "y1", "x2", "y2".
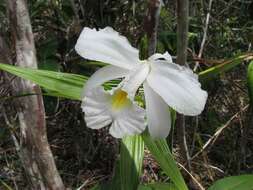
[{"x1": 75, "y1": 27, "x2": 139, "y2": 69}]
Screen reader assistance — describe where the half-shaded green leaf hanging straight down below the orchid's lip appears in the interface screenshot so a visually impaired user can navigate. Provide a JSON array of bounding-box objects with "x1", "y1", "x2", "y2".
[{"x1": 120, "y1": 135, "x2": 144, "y2": 190}]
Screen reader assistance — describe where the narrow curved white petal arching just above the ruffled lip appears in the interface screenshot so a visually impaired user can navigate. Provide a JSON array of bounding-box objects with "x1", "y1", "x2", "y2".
[{"x1": 82, "y1": 65, "x2": 129, "y2": 97}]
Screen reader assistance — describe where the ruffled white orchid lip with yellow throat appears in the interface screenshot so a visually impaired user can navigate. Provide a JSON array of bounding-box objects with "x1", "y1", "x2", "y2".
[{"x1": 82, "y1": 86, "x2": 145, "y2": 138}]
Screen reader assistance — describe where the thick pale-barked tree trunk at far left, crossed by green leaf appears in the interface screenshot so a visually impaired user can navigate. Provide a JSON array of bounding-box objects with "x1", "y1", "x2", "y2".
[{"x1": 6, "y1": 0, "x2": 65, "y2": 190}]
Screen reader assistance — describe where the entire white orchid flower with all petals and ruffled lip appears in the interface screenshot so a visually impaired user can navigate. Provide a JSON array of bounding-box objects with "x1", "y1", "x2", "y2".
[{"x1": 75, "y1": 27, "x2": 207, "y2": 138}]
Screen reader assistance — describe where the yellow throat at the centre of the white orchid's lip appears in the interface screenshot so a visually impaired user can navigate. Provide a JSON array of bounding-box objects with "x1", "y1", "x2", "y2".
[{"x1": 112, "y1": 90, "x2": 130, "y2": 110}]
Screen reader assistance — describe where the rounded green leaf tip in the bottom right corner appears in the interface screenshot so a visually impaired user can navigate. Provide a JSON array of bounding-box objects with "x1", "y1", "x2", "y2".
[{"x1": 208, "y1": 175, "x2": 253, "y2": 190}]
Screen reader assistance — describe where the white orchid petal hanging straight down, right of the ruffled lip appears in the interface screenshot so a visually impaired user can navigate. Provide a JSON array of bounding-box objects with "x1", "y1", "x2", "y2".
[{"x1": 143, "y1": 82, "x2": 171, "y2": 138}]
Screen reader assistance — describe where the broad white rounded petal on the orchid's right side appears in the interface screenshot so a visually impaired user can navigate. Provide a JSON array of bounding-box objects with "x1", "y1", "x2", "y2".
[{"x1": 147, "y1": 60, "x2": 207, "y2": 116}]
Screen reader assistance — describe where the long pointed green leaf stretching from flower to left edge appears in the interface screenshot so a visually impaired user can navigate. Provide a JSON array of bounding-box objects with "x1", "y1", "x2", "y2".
[{"x1": 0, "y1": 63, "x2": 87, "y2": 100}]
